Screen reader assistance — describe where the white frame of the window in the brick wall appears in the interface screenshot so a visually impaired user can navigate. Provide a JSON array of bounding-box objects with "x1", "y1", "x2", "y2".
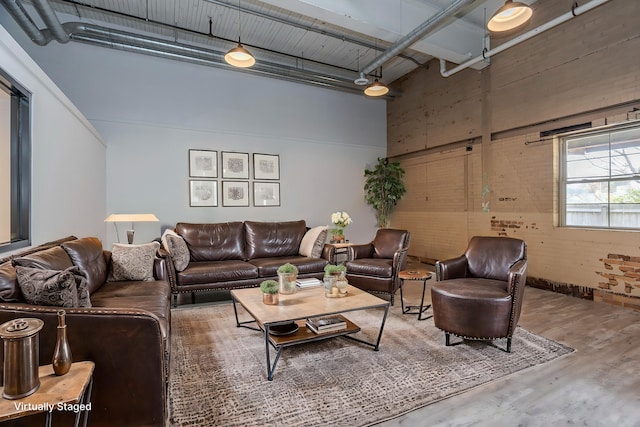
[{"x1": 556, "y1": 120, "x2": 640, "y2": 231}]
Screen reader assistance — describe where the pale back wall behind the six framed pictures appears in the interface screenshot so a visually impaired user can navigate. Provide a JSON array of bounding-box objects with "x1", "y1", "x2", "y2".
[{"x1": 0, "y1": 14, "x2": 386, "y2": 247}]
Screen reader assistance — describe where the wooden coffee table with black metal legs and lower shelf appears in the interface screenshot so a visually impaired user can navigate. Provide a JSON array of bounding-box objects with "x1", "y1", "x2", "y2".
[{"x1": 231, "y1": 286, "x2": 389, "y2": 381}]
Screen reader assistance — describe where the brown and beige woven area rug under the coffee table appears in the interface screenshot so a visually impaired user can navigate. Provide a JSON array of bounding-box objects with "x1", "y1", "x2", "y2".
[{"x1": 169, "y1": 303, "x2": 573, "y2": 427}]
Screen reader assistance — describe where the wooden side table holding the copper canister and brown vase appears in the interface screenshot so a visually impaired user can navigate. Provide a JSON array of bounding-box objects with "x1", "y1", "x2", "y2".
[{"x1": 0, "y1": 362, "x2": 95, "y2": 427}]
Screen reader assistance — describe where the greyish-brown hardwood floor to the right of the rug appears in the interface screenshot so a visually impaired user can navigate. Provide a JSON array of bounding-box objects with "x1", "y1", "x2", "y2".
[{"x1": 379, "y1": 280, "x2": 640, "y2": 427}]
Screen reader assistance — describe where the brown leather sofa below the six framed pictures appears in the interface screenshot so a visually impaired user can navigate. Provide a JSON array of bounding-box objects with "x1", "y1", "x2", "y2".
[{"x1": 167, "y1": 220, "x2": 335, "y2": 307}]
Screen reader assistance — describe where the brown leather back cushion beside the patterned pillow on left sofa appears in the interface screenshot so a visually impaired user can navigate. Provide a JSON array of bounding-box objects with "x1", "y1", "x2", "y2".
[{"x1": 61, "y1": 237, "x2": 108, "y2": 294}]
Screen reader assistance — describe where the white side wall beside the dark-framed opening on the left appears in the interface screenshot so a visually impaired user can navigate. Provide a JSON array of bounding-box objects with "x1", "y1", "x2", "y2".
[{"x1": 0, "y1": 24, "x2": 106, "y2": 251}]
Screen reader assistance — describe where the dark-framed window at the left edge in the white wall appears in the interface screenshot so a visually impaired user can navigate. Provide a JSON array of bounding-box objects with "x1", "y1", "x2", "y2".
[{"x1": 0, "y1": 70, "x2": 31, "y2": 252}]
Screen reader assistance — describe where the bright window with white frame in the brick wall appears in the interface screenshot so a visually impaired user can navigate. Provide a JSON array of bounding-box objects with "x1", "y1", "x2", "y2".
[{"x1": 560, "y1": 122, "x2": 640, "y2": 229}]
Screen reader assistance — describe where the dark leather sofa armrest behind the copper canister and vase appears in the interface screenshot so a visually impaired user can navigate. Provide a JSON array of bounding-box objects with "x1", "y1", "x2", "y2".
[{"x1": 0, "y1": 303, "x2": 167, "y2": 426}]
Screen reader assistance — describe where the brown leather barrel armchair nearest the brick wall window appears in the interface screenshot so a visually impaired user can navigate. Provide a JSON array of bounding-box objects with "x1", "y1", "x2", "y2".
[{"x1": 431, "y1": 236, "x2": 527, "y2": 352}]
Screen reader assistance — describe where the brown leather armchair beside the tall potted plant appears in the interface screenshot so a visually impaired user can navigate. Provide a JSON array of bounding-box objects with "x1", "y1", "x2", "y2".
[{"x1": 346, "y1": 228, "x2": 411, "y2": 305}]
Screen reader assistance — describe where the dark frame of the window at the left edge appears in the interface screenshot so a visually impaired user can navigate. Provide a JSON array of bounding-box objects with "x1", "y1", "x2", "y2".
[{"x1": 0, "y1": 68, "x2": 32, "y2": 253}]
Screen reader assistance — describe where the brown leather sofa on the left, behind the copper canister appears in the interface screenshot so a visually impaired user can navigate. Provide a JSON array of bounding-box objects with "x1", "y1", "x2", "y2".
[{"x1": 0, "y1": 237, "x2": 171, "y2": 427}]
